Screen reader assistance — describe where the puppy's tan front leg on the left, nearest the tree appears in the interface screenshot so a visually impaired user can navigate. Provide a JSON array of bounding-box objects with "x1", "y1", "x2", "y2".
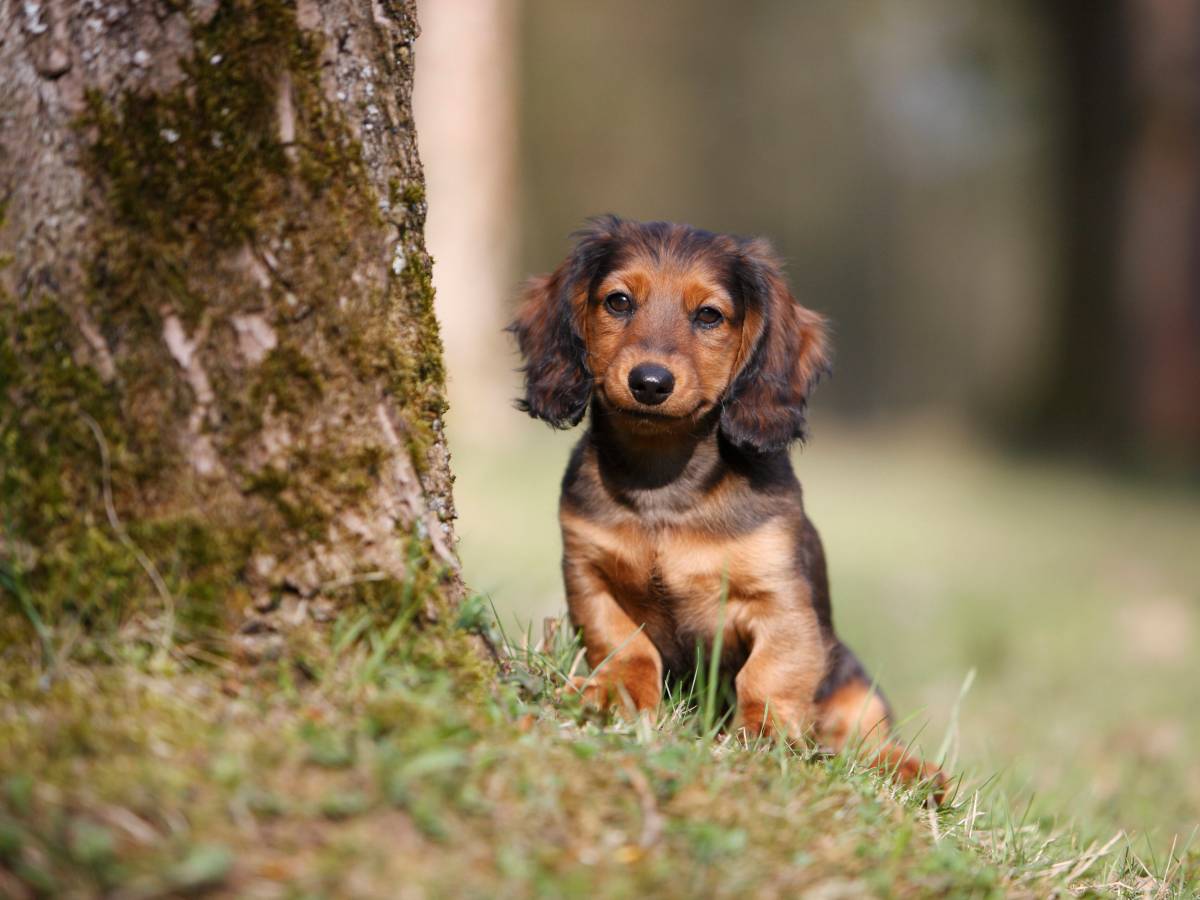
[{"x1": 564, "y1": 562, "x2": 662, "y2": 712}]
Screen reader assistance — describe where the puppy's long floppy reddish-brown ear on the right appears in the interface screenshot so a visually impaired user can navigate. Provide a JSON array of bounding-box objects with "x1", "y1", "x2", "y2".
[{"x1": 721, "y1": 241, "x2": 829, "y2": 452}]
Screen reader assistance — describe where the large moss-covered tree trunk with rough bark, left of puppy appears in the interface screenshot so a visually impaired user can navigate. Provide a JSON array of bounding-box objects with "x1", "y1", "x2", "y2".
[{"x1": 0, "y1": 0, "x2": 460, "y2": 654}]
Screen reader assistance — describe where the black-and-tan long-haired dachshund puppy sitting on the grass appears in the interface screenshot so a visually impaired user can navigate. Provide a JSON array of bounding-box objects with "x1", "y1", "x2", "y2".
[{"x1": 510, "y1": 216, "x2": 940, "y2": 796}]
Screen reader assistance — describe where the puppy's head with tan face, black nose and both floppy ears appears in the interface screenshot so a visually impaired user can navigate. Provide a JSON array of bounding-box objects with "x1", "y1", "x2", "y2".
[{"x1": 510, "y1": 216, "x2": 828, "y2": 452}]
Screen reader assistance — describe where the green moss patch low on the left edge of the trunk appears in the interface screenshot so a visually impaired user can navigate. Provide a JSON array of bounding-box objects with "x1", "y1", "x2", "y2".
[{"x1": 0, "y1": 301, "x2": 248, "y2": 626}]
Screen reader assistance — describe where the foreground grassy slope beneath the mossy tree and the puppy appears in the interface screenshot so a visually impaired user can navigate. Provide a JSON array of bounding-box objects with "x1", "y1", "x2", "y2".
[{"x1": 0, "y1": 588, "x2": 1195, "y2": 898}]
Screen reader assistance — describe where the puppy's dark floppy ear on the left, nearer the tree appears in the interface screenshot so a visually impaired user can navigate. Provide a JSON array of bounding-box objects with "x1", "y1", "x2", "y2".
[{"x1": 508, "y1": 216, "x2": 622, "y2": 428}]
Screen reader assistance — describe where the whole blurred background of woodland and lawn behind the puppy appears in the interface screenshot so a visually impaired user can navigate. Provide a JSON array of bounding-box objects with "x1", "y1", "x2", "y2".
[{"x1": 416, "y1": 0, "x2": 1200, "y2": 846}]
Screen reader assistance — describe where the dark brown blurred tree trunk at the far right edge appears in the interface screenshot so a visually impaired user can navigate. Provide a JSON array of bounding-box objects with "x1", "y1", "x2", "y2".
[{"x1": 1033, "y1": 0, "x2": 1200, "y2": 467}]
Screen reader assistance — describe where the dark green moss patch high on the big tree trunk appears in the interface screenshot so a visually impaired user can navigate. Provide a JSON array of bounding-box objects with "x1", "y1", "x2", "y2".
[{"x1": 84, "y1": 0, "x2": 359, "y2": 267}]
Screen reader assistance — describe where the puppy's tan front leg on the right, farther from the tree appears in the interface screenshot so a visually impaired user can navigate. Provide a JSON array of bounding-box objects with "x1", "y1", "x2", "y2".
[{"x1": 736, "y1": 610, "x2": 826, "y2": 738}]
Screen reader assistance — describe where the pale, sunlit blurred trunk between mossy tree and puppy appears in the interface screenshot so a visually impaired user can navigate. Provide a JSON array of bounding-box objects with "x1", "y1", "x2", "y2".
[{"x1": 413, "y1": 0, "x2": 523, "y2": 437}]
